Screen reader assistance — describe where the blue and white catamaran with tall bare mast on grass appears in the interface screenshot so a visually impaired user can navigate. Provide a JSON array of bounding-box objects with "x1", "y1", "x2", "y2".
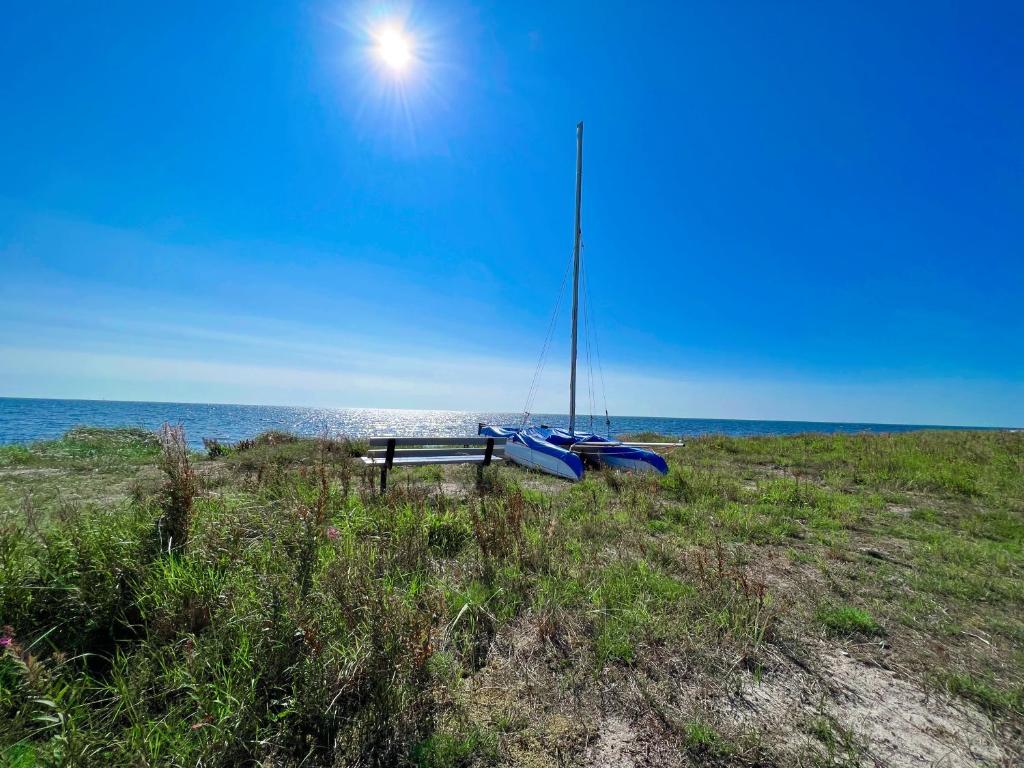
[{"x1": 478, "y1": 123, "x2": 669, "y2": 481}]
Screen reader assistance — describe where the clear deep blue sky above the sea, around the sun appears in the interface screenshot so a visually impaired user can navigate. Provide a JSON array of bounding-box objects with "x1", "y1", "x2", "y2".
[{"x1": 0, "y1": 2, "x2": 1024, "y2": 426}]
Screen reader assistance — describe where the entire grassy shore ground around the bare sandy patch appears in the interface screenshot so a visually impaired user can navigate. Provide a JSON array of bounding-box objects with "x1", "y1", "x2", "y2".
[{"x1": 0, "y1": 428, "x2": 1024, "y2": 766}]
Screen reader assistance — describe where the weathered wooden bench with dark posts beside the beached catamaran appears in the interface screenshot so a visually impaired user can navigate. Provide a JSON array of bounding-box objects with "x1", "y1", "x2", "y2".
[{"x1": 360, "y1": 436, "x2": 505, "y2": 494}]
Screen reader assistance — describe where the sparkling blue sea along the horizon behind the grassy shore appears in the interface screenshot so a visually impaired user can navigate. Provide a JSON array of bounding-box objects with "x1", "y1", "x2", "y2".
[{"x1": 0, "y1": 397, "x2": 995, "y2": 449}]
